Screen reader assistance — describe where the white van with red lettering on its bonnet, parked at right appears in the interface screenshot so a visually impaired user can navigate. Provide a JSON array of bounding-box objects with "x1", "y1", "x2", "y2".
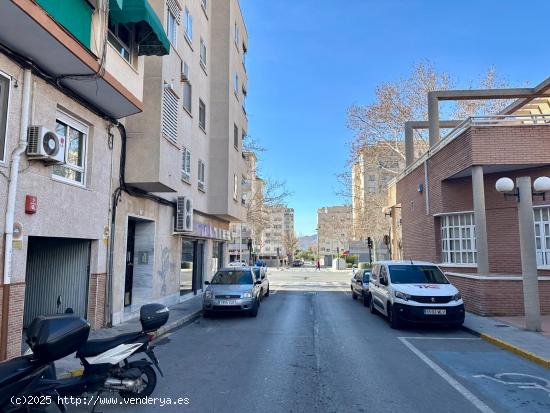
[{"x1": 369, "y1": 261, "x2": 464, "y2": 328}]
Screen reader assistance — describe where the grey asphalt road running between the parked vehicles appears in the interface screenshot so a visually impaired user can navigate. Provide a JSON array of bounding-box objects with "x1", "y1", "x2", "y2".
[{"x1": 78, "y1": 270, "x2": 550, "y2": 413}]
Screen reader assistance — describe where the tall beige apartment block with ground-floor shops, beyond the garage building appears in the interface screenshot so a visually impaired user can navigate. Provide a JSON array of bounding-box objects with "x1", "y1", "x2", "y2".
[{"x1": 112, "y1": 0, "x2": 247, "y2": 324}]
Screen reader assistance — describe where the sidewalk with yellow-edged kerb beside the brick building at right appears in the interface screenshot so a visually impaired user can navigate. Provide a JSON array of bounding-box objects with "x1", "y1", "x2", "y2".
[{"x1": 463, "y1": 313, "x2": 550, "y2": 369}]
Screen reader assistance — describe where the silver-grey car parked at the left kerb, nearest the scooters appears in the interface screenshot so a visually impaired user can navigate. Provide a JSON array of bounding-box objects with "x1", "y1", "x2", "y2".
[{"x1": 202, "y1": 267, "x2": 262, "y2": 317}]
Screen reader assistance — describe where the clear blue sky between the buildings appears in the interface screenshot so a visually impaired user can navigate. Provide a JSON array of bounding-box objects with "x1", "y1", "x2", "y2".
[{"x1": 240, "y1": 0, "x2": 550, "y2": 235}]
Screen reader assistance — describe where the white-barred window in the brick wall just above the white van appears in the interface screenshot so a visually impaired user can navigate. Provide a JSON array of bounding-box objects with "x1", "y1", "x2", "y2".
[{"x1": 441, "y1": 213, "x2": 477, "y2": 264}]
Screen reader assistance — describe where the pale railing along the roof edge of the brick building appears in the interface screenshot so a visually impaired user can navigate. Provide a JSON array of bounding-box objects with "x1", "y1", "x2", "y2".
[{"x1": 394, "y1": 114, "x2": 550, "y2": 183}]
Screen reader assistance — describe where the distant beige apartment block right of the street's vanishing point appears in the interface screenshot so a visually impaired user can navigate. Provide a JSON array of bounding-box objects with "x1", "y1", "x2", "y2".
[{"x1": 317, "y1": 205, "x2": 353, "y2": 265}]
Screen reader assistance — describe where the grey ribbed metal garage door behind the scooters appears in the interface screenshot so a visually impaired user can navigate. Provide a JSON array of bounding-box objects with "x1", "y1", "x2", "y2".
[{"x1": 23, "y1": 237, "x2": 90, "y2": 328}]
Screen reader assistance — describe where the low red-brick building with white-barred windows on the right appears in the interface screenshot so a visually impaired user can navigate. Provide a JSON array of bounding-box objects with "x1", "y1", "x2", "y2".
[{"x1": 390, "y1": 80, "x2": 550, "y2": 316}]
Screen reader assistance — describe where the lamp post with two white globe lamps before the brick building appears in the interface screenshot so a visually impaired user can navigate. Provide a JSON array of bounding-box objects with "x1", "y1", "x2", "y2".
[{"x1": 495, "y1": 176, "x2": 550, "y2": 331}]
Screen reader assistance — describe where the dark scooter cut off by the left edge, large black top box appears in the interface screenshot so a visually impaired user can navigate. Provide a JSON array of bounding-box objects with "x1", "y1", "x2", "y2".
[{"x1": 0, "y1": 315, "x2": 90, "y2": 412}]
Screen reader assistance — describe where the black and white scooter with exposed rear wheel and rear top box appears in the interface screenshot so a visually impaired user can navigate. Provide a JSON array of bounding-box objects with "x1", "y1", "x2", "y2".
[{"x1": 36, "y1": 304, "x2": 169, "y2": 411}]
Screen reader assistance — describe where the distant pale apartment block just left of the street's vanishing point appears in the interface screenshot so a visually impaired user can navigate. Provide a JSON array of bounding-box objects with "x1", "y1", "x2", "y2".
[{"x1": 258, "y1": 205, "x2": 294, "y2": 265}]
